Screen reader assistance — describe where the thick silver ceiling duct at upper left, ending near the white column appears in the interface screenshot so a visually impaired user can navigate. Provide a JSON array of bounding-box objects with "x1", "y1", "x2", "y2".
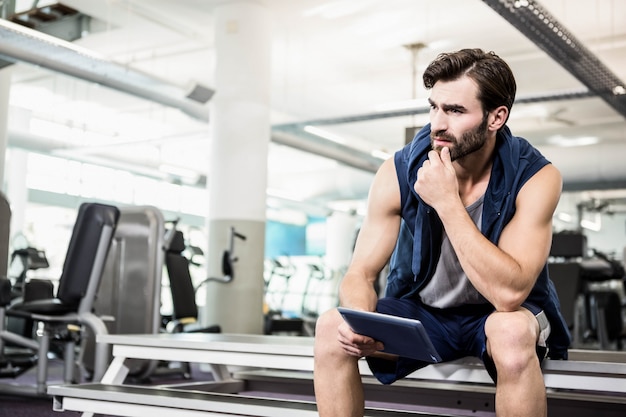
[{"x1": 0, "y1": 19, "x2": 213, "y2": 121}]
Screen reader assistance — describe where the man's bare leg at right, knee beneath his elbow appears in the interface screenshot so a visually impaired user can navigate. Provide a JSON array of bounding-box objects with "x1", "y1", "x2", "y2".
[{"x1": 485, "y1": 309, "x2": 547, "y2": 417}]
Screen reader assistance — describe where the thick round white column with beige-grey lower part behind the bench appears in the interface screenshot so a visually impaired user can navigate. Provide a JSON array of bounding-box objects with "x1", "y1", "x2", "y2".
[{"x1": 203, "y1": 2, "x2": 271, "y2": 334}]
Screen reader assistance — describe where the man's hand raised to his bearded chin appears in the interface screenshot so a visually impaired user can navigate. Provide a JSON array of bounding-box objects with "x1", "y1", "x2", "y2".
[{"x1": 414, "y1": 148, "x2": 459, "y2": 210}]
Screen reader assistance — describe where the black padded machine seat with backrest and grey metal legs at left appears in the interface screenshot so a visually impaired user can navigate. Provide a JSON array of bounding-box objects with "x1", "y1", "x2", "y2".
[{"x1": 0, "y1": 203, "x2": 120, "y2": 394}]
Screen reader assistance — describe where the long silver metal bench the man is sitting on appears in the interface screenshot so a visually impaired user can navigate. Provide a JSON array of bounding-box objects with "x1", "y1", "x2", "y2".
[{"x1": 48, "y1": 333, "x2": 626, "y2": 417}]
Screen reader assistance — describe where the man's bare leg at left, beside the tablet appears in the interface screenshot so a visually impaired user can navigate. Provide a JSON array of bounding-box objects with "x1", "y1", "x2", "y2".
[{"x1": 314, "y1": 309, "x2": 364, "y2": 417}]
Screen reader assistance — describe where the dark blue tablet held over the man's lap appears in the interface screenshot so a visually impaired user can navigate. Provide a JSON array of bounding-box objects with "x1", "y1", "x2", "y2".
[{"x1": 338, "y1": 307, "x2": 441, "y2": 363}]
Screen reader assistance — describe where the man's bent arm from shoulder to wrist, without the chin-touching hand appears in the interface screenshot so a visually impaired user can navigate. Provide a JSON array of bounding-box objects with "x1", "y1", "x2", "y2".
[{"x1": 442, "y1": 164, "x2": 562, "y2": 311}]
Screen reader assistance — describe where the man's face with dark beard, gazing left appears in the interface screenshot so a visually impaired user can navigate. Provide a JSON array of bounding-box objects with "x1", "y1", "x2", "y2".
[{"x1": 429, "y1": 77, "x2": 488, "y2": 161}]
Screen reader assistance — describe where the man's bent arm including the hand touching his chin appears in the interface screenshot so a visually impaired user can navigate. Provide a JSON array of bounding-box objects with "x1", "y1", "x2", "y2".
[{"x1": 415, "y1": 149, "x2": 562, "y2": 311}]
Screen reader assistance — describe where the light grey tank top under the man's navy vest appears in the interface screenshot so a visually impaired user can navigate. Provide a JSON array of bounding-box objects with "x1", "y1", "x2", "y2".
[{"x1": 419, "y1": 196, "x2": 487, "y2": 308}]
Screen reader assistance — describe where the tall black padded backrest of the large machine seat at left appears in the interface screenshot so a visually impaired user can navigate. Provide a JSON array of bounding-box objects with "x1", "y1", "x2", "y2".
[{"x1": 56, "y1": 203, "x2": 120, "y2": 312}]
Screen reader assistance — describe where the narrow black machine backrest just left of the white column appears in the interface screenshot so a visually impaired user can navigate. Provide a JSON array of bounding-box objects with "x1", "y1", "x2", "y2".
[{"x1": 165, "y1": 230, "x2": 198, "y2": 319}]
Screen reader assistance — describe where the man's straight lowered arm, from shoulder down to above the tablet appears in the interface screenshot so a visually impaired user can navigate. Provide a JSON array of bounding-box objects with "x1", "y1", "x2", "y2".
[{"x1": 339, "y1": 158, "x2": 401, "y2": 311}]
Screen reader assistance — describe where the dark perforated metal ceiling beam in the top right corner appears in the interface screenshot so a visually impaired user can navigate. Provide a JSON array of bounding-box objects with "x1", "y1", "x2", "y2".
[{"x1": 483, "y1": 0, "x2": 626, "y2": 117}]
